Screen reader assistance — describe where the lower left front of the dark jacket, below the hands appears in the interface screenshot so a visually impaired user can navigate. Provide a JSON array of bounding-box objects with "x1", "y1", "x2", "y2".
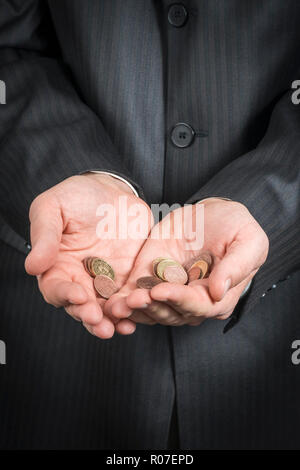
[{"x1": 0, "y1": 243, "x2": 174, "y2": 449}]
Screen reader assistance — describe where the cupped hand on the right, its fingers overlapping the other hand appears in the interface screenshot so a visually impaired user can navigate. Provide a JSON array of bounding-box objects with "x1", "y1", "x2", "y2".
[{"x1": 105, "y1": 198, "x2": 269, "y2": 326}]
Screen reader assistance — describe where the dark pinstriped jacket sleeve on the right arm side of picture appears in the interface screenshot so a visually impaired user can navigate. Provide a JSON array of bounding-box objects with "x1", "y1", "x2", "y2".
[{"x1": 188, "y1": 87, "x2": 300, "y2": 309}]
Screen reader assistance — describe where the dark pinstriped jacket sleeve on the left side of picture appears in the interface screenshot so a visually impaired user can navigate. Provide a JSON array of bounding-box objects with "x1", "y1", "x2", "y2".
[{"x1": 0, "y1": 0, "x2": 141, "y2": 239}]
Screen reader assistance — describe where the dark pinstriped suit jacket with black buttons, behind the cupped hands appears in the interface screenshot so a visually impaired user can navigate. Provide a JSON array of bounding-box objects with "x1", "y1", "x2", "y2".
[{"x1": 0, "y1": 0, "x2": 300, "y2": 448}]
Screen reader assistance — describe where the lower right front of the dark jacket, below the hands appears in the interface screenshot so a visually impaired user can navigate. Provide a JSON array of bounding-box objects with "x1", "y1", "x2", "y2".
[{"x1": 172, "y1": 272, "x2": 300, "y2": 450}]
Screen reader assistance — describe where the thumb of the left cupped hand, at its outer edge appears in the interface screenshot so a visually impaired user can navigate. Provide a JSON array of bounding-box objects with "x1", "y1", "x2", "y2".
[{"x1": 25, "y1": 196, "x2": 63, "y2": 275}]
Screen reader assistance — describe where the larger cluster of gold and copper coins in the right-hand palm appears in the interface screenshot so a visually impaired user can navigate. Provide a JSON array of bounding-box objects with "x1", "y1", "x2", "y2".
[{"x1": 136, "y1": 252, "x2": 213, "y2": 289}]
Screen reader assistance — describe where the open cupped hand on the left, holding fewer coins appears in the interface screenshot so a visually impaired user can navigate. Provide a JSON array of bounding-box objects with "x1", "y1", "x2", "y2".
[{"x1": 25, "y1": 173, "x2": 152, "y2": 338}]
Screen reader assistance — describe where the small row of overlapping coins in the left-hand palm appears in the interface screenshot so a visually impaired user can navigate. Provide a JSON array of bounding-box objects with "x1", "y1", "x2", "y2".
[{"x1": 83, "y1": 256, "x2": 118, "y2": 299}]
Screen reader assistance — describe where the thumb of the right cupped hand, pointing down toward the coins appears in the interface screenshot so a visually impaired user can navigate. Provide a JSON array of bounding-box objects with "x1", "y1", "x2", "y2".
[{"x1": 209, "y1": 228, "x2": 268, "y2": 301}]
